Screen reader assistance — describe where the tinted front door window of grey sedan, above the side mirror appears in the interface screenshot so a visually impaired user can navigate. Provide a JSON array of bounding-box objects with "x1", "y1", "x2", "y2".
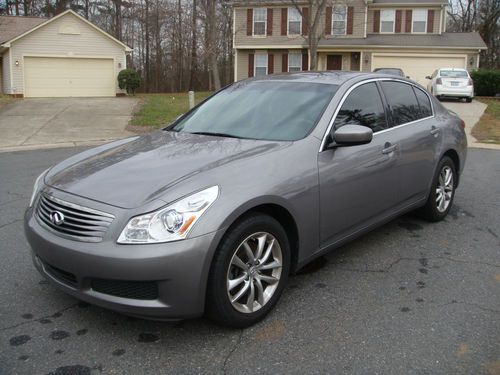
[{"x1": 335, "y1": 83, "x2": 387, "y2": 132}]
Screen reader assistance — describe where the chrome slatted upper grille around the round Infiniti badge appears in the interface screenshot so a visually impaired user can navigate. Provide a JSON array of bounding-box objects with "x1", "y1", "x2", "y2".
[{"x1": 36, "y1": 194, "x2": 114, "y2": 242}]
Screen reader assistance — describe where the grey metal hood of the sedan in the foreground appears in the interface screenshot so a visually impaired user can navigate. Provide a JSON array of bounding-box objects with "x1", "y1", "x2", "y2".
[{"x1": 45, "y1": 131, "x2": 289, "y2": 208}]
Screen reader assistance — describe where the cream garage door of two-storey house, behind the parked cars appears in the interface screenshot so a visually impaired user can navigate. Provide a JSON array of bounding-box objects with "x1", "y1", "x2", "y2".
[{"x1": 372, "y1": 55, "x2": 465, "y2": 86}]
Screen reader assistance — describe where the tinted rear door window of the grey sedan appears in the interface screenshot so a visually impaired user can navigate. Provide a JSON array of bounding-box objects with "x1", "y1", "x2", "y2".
[{"x1": 381, "y1": 81, "x2": 420, "y2": 126}]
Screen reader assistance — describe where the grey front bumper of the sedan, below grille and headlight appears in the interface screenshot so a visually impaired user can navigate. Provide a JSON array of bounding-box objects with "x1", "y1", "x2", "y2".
[{"x1": 25, "y1": 209, "x2": 223, "y2": 320}]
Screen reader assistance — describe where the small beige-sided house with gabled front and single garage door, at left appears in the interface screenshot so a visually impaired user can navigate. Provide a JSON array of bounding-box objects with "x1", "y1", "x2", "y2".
[{"x1": 0, "y1": 10, "x2": 131, "y2": 97}]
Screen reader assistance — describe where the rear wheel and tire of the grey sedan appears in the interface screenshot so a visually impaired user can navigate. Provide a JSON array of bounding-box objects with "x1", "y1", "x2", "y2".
[{"x1": 420, "y1": 156, "x2": 457, "y2": 222}]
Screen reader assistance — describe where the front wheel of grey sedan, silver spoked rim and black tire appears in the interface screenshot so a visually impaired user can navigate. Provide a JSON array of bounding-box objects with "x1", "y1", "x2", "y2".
[{"x1": 205, "y1": 214, "x2": 291, "y2": 328}]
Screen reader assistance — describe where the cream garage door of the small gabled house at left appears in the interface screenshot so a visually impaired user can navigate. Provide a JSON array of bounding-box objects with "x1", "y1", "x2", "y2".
[{"x1": 24, "y1": 57, "x2": 116, "y2": 97}]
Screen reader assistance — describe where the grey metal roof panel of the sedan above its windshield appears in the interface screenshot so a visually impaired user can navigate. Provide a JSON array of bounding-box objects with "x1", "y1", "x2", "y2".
[{"x1": 248, "y1": 71, "x2": 400, "y2": 85}]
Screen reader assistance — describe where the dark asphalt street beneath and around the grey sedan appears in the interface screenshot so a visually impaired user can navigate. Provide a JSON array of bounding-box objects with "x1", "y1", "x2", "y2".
[{"x1": 0, "y1": 148, "x2": 500, "y2": 375}]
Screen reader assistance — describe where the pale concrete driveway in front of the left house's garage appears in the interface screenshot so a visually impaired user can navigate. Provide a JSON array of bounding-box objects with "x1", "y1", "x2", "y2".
[{"x1": 0, "y1": 97, "x2": 137, "y2": 152}]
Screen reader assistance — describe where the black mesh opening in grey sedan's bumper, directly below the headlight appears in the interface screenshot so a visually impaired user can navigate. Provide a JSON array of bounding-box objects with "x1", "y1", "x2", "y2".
[{"x1": 91, "y1": 279, "x2": 158, "y2": 300}]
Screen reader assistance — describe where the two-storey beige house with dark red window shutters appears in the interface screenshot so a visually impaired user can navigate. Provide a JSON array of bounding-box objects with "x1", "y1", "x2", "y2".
[{"x1": 233, "y1": 0, "x2": 486, "y2": 84}]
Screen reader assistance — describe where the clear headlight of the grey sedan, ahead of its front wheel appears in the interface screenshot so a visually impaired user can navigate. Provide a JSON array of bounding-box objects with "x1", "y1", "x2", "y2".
[{"x1": 118, "y1": 186, "x2": 219, "y2": 244}]
